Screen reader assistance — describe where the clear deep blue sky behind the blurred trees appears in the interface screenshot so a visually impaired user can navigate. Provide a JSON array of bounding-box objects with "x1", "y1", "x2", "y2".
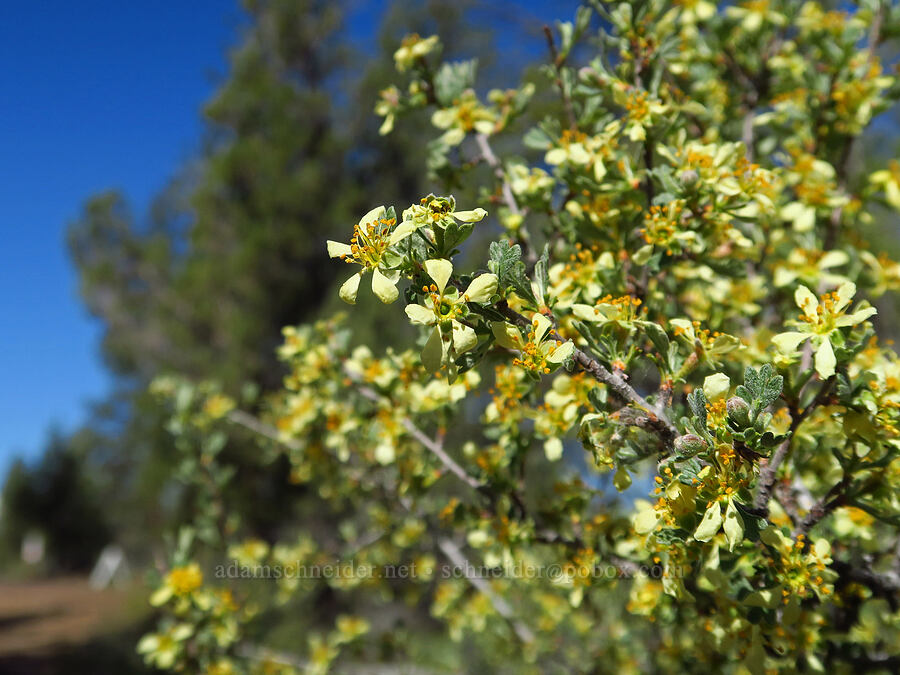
[{"x1": 0, "y1": 0, "x2": 577, "y2": 479}]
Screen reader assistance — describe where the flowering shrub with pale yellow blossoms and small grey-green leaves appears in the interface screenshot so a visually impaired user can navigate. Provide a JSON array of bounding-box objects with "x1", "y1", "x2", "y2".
[{"x1": 141, "y1": 0, "x2": 900, "y2": 673}]
